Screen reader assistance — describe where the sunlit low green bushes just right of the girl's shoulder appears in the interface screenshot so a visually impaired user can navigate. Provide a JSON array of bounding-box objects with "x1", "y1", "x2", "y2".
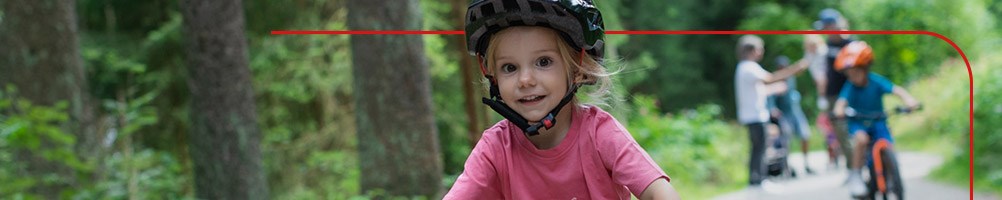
[{"x1": 625, "y1": 96, "x2": 747, "y2": 198}]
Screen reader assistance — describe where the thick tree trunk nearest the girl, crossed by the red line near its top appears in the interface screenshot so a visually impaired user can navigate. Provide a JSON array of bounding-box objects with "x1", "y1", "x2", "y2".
[{"x1": 348, "y1": 0, "x2": 442, "y2": 198}]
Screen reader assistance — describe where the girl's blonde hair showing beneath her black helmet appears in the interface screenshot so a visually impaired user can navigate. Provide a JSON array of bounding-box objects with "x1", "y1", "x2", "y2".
[{"x1": 484, "y1": 28, "x2": 618, "y2": 105}]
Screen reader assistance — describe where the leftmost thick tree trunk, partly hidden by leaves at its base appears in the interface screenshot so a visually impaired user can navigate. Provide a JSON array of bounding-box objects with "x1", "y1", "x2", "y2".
[{"x1": 0, "y1": 0, "x2": 98, "y2": 198}]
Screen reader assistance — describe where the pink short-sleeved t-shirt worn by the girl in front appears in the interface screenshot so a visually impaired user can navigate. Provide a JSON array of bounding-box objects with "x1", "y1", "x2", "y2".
[{"x1": 445, "y1": 106, "x2": 670, "y2": 199}]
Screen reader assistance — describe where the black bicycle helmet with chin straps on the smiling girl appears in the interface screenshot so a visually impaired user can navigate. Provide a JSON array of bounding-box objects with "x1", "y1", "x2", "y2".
[{"x1": 458, "y1": 0, "x2": 605, "y2": 136}]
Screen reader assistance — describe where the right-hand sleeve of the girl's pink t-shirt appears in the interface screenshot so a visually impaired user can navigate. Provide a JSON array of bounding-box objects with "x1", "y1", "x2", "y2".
[{"x1": 596, "y1": 117, "x2": 671, "y2": 197}]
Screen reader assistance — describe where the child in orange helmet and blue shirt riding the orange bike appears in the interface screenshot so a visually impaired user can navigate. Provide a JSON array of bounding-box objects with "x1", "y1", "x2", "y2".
[{"x1": 834, "y1": 41, "x2": 919, "y2": 196}]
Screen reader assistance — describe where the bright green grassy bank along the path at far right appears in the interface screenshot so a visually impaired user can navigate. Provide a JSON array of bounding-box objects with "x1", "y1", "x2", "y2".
[{"x1": 888, "y1": 53, "x2": 1002, "y2": 196}]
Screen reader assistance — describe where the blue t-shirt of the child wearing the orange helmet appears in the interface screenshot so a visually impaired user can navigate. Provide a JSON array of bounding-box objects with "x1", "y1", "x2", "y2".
[{"x1": 839, "y1": 72, "x2": 894, "y2": 116}]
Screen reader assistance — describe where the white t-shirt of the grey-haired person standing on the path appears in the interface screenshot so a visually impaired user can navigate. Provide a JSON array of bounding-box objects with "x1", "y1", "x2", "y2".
[{"x1": 734, "y1": 60, "x2": 769, "y2": 124}]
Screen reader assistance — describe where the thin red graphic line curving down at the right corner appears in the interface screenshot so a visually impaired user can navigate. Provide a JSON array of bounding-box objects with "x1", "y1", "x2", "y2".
[{"x1": 272, "y1": 30, "x2": 974, "y2": 199}]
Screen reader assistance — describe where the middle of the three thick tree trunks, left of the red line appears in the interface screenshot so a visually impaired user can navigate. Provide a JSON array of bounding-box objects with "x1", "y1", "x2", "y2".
[{"x1": 180, "y1": 0, "x2": 269, "y2": 199}]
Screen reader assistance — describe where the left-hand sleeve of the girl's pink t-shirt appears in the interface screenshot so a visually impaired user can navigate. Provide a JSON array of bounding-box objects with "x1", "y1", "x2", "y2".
[{"x1": 443, "y1": 133, "x2": 502, "y2": 199}]
